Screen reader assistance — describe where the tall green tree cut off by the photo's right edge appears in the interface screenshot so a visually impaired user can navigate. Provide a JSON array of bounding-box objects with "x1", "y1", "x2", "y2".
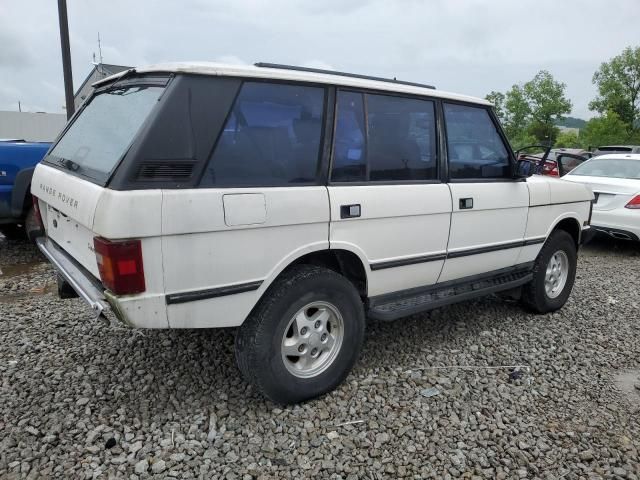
[{"x1": 589, "y1": 47, "x2": 640, "y2": 129}]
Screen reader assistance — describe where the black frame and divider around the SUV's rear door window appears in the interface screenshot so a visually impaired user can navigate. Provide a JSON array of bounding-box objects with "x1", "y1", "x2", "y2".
[{"x1": 327, "y1": 85, "x2": 443, "y2": 187}]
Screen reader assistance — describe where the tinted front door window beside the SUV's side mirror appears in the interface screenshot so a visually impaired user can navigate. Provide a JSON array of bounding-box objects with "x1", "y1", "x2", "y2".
[{"x1": 444, "y1": 103, "x2": 511, "y2": 178}]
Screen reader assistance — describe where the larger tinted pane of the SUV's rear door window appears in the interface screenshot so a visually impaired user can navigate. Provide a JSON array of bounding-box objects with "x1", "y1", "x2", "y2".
[{"x1": 366, "y1": 95, "x2": 436, "y2": 181}]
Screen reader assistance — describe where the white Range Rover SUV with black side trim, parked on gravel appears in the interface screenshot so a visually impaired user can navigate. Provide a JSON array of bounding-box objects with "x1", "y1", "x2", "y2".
[{"x1": 32, "y1": 63, "x2": 592, "y2": 403}]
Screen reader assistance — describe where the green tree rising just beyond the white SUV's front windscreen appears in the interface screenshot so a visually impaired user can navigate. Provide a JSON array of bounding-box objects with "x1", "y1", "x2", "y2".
[{"x1": 522, "y1": 70, "x2": 571, "y2": 143}]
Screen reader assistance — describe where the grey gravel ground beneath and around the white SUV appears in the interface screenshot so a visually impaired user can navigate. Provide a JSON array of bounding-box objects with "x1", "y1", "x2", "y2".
[{"x1": 0, "y1": 233, "x2": 640, "y2": 479}]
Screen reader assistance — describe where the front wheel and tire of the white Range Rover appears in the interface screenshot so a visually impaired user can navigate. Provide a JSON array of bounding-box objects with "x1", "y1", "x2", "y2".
[{"x1": 522, "y1": 230, "x2": 577, "y2": 313}]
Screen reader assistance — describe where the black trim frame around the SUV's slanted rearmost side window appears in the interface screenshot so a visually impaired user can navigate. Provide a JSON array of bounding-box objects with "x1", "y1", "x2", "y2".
[{"x1": 199, "y1": 77, "x2": 335, "y2": 190}]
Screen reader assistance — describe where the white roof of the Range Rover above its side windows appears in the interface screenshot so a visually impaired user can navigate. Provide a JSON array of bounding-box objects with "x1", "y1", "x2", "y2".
[{"x1": 93, "y1": 62, "x2": 491, "y2": 105}]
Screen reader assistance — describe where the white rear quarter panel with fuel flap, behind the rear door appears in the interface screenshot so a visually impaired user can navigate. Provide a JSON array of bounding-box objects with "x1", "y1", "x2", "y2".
[{"x1": 162, "y1": 187, "x2": 329, "y2": 328}]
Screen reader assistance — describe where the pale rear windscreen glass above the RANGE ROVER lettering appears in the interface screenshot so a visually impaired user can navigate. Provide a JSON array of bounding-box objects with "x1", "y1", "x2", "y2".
[{"x1": 48, "y1": 85, "x2": 164, "y2": 182}]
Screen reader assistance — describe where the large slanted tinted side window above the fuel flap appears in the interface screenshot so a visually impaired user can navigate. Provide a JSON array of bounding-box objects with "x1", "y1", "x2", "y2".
[{"x1": 202, "y1": 82, "x2": 324, "y2": 186}]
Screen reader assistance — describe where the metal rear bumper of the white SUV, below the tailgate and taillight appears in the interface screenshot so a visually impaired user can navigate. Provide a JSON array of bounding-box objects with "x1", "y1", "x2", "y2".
[{"x1": 36, "y1": 237, "x2": 110, "y2": 317}]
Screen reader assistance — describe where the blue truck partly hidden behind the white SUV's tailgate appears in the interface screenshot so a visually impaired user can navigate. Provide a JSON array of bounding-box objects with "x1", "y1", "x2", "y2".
[{"x1": 0, "y1": 140, "x2": 51, "y2": 242}]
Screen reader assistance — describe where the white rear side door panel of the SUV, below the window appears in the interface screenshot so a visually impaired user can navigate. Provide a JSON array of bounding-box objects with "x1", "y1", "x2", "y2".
[{"x1": 329, "y1": 184, "x2": 451, "y2": 296}]
